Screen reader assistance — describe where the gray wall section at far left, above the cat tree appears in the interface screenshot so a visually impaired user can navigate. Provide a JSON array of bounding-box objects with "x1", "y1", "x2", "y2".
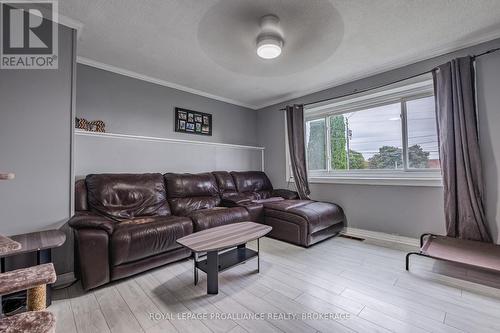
[{"x1": 0, "y1": 26, "x2": 75, "y2": 272}]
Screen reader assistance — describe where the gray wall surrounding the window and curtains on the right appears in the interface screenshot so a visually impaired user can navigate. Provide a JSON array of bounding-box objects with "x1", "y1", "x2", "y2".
[{"x1": 257, "y1": 39, "x2": 500, "y2": 240}]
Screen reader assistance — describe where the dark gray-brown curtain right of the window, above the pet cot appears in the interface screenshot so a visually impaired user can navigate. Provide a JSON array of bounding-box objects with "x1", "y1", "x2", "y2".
[{"x1": 433, "y1": 57, "x2": 491, "y2": 242}]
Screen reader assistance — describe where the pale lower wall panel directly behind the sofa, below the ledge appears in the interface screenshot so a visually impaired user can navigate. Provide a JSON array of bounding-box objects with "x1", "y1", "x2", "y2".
[{"x1": 75, "y1": 134, "x2": 262, "y2": 178}]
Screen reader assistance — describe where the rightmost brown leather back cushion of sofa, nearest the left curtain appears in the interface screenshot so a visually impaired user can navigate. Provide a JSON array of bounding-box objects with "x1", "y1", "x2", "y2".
[{"x1": 231, "y1": 171, "x2": 273, "y2": 199}]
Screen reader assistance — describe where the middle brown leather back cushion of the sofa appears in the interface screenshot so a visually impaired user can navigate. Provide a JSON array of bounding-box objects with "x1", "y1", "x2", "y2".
[{"x1": 164, "y1": 173, "x2": 220, "y2": 216}]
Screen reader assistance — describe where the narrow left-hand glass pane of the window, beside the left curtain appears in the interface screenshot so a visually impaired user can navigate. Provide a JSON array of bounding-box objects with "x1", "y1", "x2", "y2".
[{"x1": 305, "y1": 119, "x2": 326, "y2": 170}]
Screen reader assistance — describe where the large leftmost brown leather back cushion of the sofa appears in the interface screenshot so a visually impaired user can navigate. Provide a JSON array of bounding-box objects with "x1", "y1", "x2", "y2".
[{"x1": 85, "y1": 173, "x2": 170, "y2": 221}]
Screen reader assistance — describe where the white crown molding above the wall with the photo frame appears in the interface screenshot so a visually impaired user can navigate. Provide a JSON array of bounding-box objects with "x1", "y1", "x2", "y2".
[{"x1": 76, "y1": 56, "x2": 257, "y2": 110}]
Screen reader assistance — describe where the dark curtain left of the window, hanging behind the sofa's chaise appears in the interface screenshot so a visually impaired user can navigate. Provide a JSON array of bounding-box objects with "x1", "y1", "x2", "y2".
[{"x1": 286, "y1": 104, "x2": 311, "y2": 200}]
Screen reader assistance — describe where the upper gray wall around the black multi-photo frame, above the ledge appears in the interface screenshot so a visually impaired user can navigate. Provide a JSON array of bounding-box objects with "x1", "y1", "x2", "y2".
[{"x1": 76, "y1": 64, "x2": 258, "y2": 145}]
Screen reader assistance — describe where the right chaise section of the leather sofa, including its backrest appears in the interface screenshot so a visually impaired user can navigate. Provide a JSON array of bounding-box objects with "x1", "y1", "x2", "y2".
[{"x1": 214, "y1": 171, "x2": 345, "y2": 247}]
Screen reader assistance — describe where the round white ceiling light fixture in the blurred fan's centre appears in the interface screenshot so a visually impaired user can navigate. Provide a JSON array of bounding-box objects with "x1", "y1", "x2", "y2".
[{"x1": 257, "y1": 14, "x2": 284, "y2": 59}]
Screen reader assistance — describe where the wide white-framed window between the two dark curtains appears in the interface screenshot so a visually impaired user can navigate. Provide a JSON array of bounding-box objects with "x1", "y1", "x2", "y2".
[{"x1": 298, "y1": 79, "x2": 441, "y2": 185}]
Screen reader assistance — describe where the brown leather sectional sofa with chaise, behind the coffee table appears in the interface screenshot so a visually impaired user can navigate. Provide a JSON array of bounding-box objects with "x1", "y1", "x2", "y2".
[{"x1": 69, "y1": 171, "x2": 345, "y2": 290}]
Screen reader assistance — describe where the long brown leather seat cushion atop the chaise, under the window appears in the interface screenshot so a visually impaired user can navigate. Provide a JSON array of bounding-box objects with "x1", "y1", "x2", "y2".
[{"x1": 264, "y1": 200, "x2": 344, "y2": 234}]
